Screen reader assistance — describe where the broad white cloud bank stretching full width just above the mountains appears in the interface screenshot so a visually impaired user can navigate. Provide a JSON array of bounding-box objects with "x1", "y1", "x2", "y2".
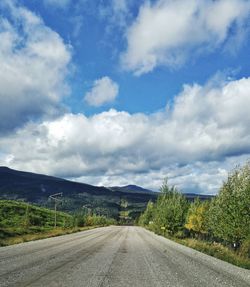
[{"x1": 0, "y1": 78, "x2": 250, "y2": 193}]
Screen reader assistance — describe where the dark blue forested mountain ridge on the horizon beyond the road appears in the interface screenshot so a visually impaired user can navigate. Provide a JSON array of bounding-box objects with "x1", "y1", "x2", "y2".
[{"x1": 0, "y1": 167, "x2": 211, "y2": 218}]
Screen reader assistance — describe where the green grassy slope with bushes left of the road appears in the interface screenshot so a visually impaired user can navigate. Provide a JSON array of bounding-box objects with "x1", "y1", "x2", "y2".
[{"x1": 0, "y1": 200, "x2": 114, "y2": 249}]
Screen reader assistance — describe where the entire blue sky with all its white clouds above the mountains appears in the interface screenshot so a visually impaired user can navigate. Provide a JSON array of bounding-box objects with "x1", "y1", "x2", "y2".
[{"x1": 0, "y1": 0, "x2": 250, "y2": 193}]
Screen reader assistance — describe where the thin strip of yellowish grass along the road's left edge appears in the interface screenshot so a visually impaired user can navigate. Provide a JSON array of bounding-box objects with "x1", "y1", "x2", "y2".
[{"x1": 0, "y1": 226, "x2": 100, "y2": 246}]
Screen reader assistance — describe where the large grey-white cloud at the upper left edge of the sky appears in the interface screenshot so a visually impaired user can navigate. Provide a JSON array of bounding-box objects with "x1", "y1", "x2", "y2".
[{"x1": 0, "y1": 0, "x2": 71, "y2": 132}]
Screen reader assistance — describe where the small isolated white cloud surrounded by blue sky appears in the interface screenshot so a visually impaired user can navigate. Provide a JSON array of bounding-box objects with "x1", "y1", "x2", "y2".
[{"x1": 84, "y1": 77, "x2": 119, "y2": 107}]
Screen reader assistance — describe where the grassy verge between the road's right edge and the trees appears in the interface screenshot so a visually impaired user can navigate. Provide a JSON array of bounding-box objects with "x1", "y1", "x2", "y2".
[{"x1": 146, "y1": 229, "x2": 250, "y2": 269}]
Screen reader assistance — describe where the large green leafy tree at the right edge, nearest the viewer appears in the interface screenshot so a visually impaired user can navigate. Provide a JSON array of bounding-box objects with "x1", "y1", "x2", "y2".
[{"x1": 208, "y1": 162, "x2": 250, "y2": 246}]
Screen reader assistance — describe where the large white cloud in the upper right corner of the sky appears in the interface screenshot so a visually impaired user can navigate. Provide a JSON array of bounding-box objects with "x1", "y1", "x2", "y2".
[{"x1": 121, "y1": 0, "x2": 250, "y2": 75}]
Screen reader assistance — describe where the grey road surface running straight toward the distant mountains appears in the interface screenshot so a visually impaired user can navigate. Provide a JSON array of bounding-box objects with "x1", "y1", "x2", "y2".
[{"x1": 0, "y1": 226, "x2": 250, "y2": 287}]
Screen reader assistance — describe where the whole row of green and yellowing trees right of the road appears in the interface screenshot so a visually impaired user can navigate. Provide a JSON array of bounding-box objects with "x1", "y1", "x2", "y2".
[{"x1": 139, "y1": 162, "x2": 250, "y2": 257}]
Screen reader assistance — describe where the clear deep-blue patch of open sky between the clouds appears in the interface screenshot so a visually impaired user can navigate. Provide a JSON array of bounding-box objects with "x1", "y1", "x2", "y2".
[{"x1": 17, "y1": 0, "x2": 250, "y2": 114}]
